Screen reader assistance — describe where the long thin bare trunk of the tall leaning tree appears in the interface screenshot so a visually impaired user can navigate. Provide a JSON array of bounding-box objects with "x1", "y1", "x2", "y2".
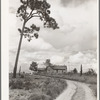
[{"x1": 13, "y1": 21, "x2": 25, "y2": 78}]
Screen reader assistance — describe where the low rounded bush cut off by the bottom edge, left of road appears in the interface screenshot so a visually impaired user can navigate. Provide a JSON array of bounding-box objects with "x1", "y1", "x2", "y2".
[{"x1": 28, "y1": 93, "x2": 53, "y2": 100}]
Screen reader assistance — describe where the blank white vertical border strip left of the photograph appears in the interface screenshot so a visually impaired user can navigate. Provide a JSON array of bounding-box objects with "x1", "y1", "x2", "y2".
[{"x1": 1, "y1": 0, "x2": 10, "y2": 100}]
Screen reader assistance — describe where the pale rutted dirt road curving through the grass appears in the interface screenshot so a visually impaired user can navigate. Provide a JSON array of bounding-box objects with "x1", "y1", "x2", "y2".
[{"x1": 55, "y1": 80, "x2": 96, "y2": 100}]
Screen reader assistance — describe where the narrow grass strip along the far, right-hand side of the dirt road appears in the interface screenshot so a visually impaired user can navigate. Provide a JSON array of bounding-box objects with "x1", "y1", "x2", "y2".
[{"x1": 38, "y1": 73, "x2": 97, "y2": 97}]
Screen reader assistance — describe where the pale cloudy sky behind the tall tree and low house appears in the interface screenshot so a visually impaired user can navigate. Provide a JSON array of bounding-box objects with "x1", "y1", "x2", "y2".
[{"x1": 9, "y1": 0, "x2": 97, "y2": 72}]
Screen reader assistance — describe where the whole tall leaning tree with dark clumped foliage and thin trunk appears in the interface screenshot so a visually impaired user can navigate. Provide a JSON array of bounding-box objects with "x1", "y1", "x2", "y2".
[{"x1": 13, "y1": 0, "x2": 59, "y2": 78}]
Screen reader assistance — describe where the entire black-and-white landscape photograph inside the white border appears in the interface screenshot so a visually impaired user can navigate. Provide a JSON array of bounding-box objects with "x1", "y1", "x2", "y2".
[{"x1": 8, "y1": 0, "x2": 99, "y2": 100}]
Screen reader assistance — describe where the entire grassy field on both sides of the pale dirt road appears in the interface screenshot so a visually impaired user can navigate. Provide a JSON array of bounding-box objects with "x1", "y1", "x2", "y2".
[{"x1": 9, "y1": 74, "x2": 97, "y2": 100}]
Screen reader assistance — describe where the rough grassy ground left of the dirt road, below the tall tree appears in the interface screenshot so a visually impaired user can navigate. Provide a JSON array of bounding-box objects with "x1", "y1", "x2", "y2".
[{"x1": 9, "y1": 75, "x2": 67, "y2": 100}]
